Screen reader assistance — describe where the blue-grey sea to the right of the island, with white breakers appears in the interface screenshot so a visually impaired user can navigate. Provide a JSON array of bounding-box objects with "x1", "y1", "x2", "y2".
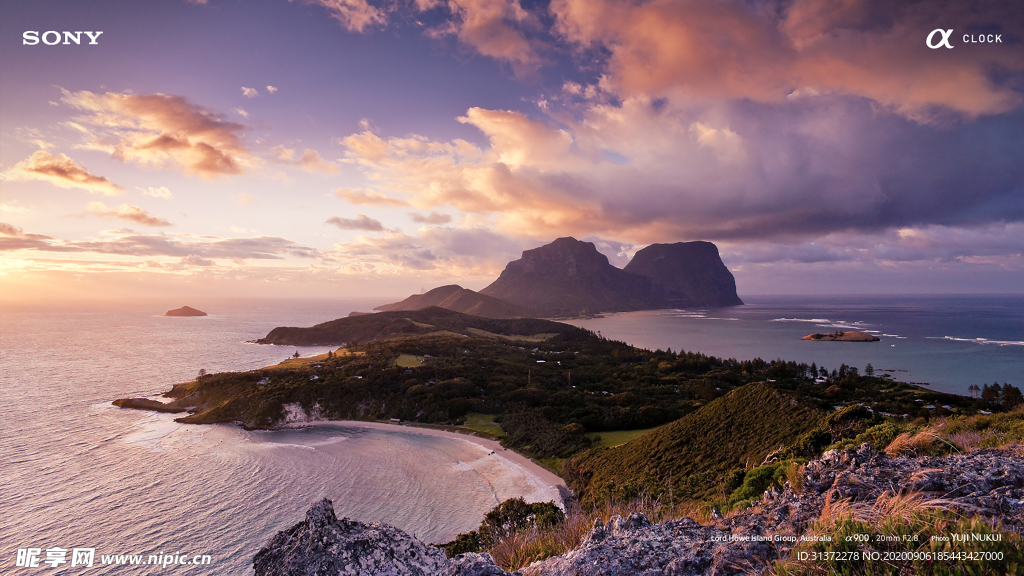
[{"x1": 569, "y1": 296, "x2": 1024, "y2": 395}]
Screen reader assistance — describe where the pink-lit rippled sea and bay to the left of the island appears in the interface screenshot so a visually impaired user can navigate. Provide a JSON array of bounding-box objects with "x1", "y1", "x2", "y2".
[{"x1": 0, "y1": 301, "x2": 557, "y2": 575}]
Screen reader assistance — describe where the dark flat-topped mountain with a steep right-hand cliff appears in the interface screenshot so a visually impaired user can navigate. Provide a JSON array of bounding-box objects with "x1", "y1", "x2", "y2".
[{"x1": 623, "y1": 242, "x2": 743, "y2": 307}]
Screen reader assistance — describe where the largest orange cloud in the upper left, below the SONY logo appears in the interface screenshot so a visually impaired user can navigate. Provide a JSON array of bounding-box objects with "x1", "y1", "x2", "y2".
[{"x1": 62, "y1": 90, "x2": 253, "y2": 178}]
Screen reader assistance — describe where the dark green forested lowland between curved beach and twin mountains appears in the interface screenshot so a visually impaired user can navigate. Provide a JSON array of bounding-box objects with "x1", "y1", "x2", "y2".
[{"x1": 112, "y1": 307, "x2": 1005, "y2": 502}]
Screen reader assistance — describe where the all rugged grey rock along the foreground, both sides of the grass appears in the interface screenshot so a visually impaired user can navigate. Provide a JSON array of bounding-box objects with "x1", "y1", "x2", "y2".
[{"x1": 253, "y1": 444, "x2": 1024, "y2": 576}]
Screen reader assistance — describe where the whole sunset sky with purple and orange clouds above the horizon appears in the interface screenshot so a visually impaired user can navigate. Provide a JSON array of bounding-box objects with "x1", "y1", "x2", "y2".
[{"x1": 0, "y1": 0, "x2": 1024, "y2": 301}]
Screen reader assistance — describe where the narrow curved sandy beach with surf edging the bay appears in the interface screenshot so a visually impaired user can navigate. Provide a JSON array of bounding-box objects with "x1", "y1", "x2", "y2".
[{"x1": 279, "y1": 420, "x2": 571, "y2": 508}]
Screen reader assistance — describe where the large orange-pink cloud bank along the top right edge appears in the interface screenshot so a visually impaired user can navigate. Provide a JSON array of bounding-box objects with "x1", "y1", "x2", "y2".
[{"x1": 552, "y1": 0, "x2": 1024, "y2": 120}]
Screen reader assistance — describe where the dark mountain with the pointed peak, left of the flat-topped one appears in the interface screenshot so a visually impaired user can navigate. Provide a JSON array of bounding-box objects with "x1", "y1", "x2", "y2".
[{"x1": 480, "y1": 238, "x2": 657, "y2": 316}]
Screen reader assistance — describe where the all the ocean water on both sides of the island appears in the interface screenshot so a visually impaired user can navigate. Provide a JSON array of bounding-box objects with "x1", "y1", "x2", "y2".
[{"x1": 0, "y1": 296, "x2": 1024, "y2": 574}]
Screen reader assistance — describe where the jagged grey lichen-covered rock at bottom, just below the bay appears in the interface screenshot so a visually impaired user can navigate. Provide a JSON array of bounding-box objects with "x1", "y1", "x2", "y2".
[{"x1": 253, "y1": 498, "x2": 449, "y2": 576}]
